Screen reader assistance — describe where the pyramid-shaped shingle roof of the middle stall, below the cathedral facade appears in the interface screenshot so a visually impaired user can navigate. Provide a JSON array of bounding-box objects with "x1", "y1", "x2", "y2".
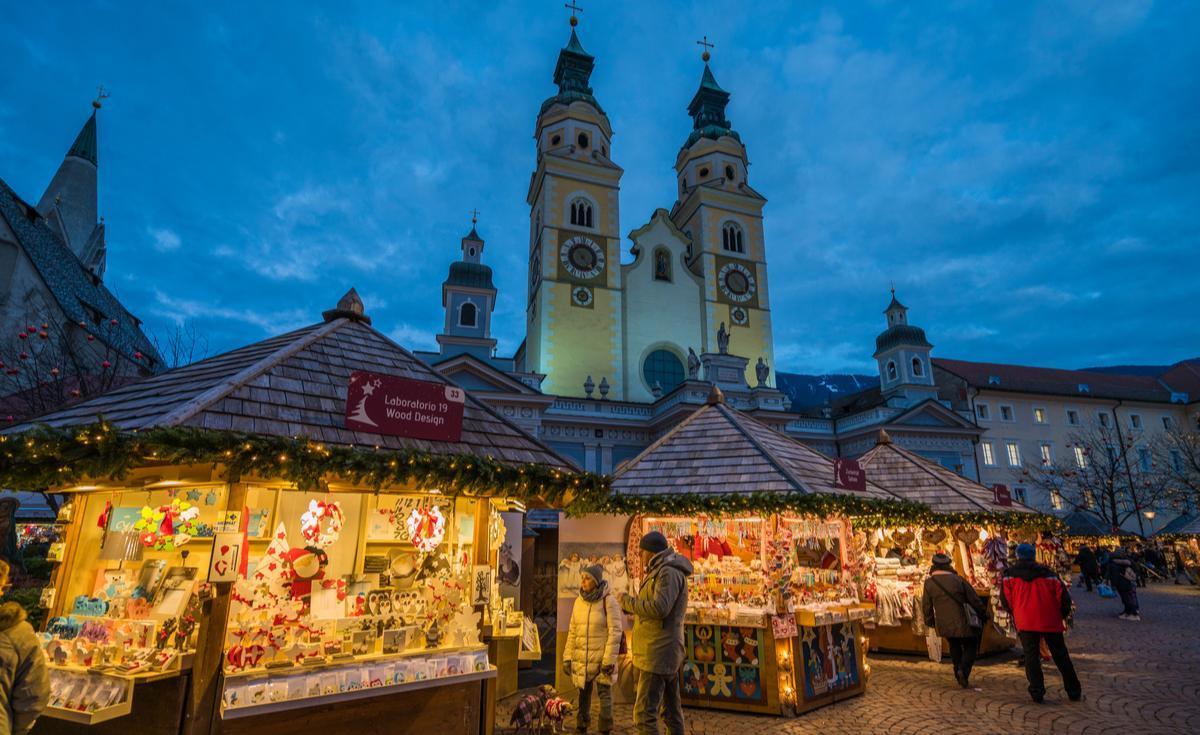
[{"x1": 612, "y1": 390, "x2": 898, "y2": 498}]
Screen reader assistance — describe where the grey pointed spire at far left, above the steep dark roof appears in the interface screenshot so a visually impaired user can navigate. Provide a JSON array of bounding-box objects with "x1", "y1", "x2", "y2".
[{"x1": 37, "y1": 96, "x2": 107, "y2": 279}]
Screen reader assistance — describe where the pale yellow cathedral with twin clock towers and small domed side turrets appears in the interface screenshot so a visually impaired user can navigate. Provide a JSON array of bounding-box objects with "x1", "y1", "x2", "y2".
[{"x1": 418, "y1": 18, "x2": 980, "y2": 477}]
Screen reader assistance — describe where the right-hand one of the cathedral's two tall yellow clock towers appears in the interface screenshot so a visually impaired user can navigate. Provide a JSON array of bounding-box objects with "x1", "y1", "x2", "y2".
[{"x1": 671, "y1": 40, "x2": 775, "y2": 386}]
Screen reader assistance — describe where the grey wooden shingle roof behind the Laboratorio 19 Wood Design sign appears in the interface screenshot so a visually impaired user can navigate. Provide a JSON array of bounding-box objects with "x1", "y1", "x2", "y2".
[{"x1": 8, "y1": 291, "x2": 577, "y2": 471}]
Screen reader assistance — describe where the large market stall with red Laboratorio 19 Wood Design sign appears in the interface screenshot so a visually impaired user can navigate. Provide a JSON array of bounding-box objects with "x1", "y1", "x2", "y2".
[{"x1": 0, "y1": 293, "x2": 585, "y2": 735}]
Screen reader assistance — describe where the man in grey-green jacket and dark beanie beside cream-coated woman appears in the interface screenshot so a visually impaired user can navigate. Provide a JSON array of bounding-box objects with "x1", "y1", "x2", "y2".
[{"x1": 620, "y1": 531, "x2": 692, "y2": 735}]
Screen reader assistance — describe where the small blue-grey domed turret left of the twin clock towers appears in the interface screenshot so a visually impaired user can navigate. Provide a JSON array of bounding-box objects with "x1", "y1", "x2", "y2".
[{"x1": 437, "y1": 216, "x2": 496, "y2": 361}]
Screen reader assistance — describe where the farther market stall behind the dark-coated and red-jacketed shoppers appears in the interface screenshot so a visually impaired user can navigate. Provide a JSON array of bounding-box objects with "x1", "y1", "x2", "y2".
[{"x1": 858, "y1": 430, "x2": 1061, "y2": 655}]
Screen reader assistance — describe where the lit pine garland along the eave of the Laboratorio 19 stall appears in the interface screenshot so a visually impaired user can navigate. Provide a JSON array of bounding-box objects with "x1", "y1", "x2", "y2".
[{"x1": 0, "y1": 419, "x2": 608, "y2": 504}]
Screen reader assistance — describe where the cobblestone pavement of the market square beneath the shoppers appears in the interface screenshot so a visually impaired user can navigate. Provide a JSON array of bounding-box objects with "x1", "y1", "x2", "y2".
[{"x1": 498, "y1": 584, "x2": 1200, "y2": 735}]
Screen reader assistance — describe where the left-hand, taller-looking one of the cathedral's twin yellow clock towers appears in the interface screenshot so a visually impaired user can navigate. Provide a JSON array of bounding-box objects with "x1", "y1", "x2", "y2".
[{"x1": 524, "y1": 16, "x2": 625, "y2": 399}]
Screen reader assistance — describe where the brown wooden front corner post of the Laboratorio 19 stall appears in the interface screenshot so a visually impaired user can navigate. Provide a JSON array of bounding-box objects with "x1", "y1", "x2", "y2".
[{"x1": 182, "y1": 483, "x2": 250, "y2": 735}]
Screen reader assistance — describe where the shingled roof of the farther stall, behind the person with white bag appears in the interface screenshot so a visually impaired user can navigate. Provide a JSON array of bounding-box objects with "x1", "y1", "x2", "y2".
[{"x1": 858, "y1": 430, "x2": 1036, "y2": 513}]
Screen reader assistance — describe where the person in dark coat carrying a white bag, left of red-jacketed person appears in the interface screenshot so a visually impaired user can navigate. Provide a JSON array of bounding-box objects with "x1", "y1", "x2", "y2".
[{"x1": 922, "y1": 554, "x2": 988, "y2": 689}]
